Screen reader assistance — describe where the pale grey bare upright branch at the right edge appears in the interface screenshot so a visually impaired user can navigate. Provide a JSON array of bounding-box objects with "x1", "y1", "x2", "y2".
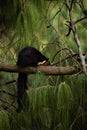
[{"x1": 66, "y1": 0, "x2": 87, "y2": 75}]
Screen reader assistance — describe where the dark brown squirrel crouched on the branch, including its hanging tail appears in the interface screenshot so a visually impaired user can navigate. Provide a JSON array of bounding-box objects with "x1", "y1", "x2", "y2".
[{"x1": 17, "y1": 46, "x2": 50, "y2": 112}]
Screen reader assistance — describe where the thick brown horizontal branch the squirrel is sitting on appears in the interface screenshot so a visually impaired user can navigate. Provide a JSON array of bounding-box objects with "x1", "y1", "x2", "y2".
[{"x1": 0, "y1": 63, "x2": 76, "y2": 75}]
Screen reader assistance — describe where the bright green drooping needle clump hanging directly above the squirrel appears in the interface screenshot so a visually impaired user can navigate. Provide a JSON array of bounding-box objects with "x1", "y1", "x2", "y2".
[{"x1": 16, "y1": 3, "x2": 43, "y2": 45}]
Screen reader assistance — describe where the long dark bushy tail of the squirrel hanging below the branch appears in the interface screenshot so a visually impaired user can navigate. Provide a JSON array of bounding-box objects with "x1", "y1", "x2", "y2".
[{"x1": 17, "y1": 73, "x2": 28, "y2": 112}]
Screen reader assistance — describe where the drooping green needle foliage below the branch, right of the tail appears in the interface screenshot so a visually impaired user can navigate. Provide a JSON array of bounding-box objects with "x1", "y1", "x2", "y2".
[{"x1": 10, "y1": 75, "x2": 87, "y2": 130}]
